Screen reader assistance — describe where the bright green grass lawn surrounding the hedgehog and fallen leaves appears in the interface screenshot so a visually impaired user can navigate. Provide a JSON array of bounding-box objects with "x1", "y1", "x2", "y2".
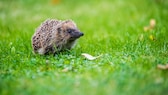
[{"x1": 0, "y1": 0, "x2": 168, "y2": 95}]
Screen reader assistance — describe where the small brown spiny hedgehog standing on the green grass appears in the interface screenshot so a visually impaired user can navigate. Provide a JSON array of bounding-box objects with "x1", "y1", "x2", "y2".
[{"x1": 32, "y1": 19, "x2": 84, "y2": 55}]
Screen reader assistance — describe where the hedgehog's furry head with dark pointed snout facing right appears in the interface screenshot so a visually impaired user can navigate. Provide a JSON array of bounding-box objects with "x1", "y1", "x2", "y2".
[{"x1": 58, "y1": 20, "x2": 84, "y2": 41}]
